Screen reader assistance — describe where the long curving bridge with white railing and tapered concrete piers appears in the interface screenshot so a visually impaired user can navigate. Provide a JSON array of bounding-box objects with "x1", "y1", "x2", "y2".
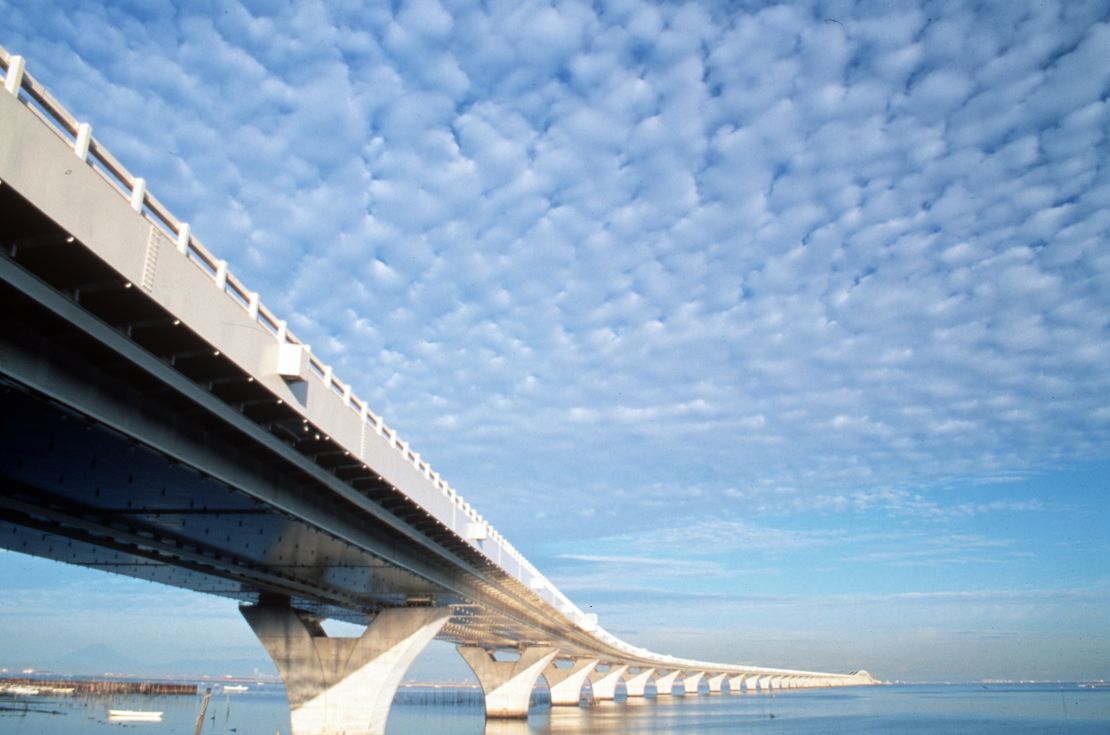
[{"x1": 0, "y1": 48, "x2": 874, "y2": 735}]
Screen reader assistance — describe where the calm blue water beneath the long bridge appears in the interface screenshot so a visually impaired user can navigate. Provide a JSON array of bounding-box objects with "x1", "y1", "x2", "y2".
[{"x1": 0, "y1": 685, "x2": 1110, "y2": 735}]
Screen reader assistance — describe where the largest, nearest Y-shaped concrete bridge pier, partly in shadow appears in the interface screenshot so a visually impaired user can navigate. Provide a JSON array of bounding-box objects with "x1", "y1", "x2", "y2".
[{"x1": 240, "y1": 605, "x2": 451, "y2": 735}]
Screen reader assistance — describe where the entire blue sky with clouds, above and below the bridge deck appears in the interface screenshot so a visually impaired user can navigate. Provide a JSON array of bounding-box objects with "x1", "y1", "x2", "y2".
[{"x1": 0, "y1": 0, "x2": 1110, "y2": 681}]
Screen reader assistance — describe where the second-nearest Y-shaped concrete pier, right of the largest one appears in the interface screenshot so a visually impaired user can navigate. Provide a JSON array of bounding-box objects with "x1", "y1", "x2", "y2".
[{"x1": 458, "y1": 646, "x2": 558, "y2": 719}]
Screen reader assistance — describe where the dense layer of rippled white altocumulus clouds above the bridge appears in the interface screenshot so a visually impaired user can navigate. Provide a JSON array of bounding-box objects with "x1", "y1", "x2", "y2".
[{"x1": 0, "y1": 0, "x2": 1110, "y2": 535}]
